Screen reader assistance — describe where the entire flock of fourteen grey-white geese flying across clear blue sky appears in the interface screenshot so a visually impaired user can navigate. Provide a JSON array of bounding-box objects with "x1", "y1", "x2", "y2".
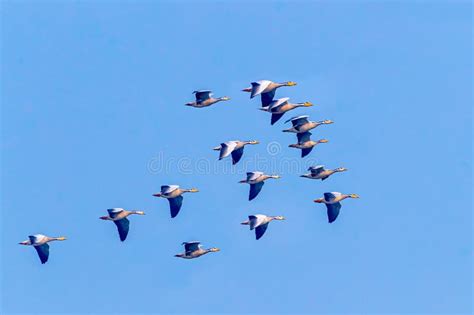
[{"x1": 19, "y1": 80, "x2": 359, "y2": 264}]
